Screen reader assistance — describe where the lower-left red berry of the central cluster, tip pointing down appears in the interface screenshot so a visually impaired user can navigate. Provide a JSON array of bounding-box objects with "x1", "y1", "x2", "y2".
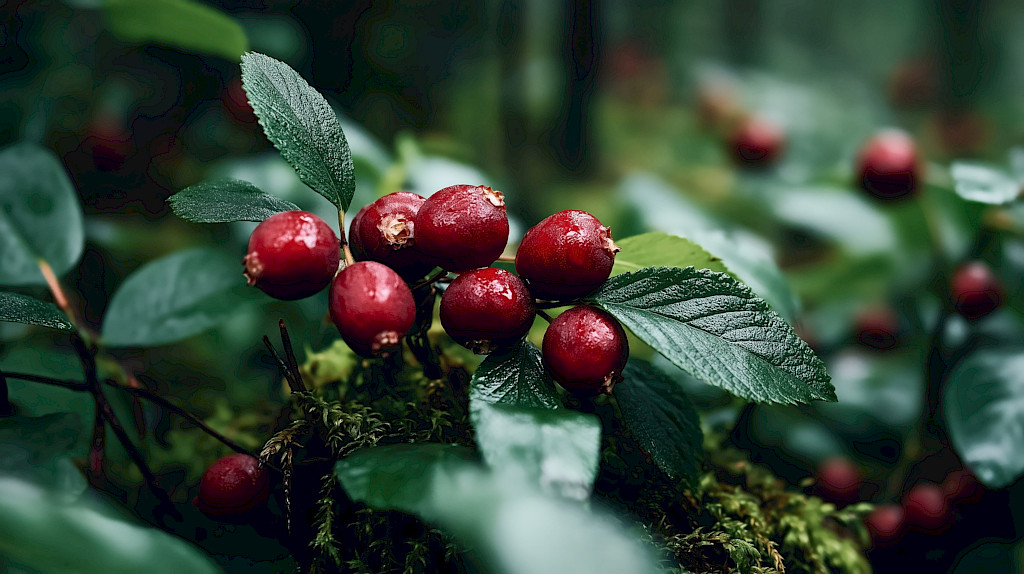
[{"x1": 329, "y1": 261, "x2": 416, "y2": 357}]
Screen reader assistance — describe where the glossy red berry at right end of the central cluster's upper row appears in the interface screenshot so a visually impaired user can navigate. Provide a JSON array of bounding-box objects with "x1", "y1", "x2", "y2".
[{"x1": 515, "y1": 210, "x2": 620, "y2": 300}]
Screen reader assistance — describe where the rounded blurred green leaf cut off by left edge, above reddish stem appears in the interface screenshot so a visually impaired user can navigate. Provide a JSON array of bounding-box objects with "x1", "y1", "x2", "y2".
[{"x1": 0, "y1": 143, "x2": 85, "y2": 285}]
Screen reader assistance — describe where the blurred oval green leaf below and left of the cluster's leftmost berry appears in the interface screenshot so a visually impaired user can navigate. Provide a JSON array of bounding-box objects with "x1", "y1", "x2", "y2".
[{"x1": 102, "y1": 248, "x2": 244, "y2": 347}]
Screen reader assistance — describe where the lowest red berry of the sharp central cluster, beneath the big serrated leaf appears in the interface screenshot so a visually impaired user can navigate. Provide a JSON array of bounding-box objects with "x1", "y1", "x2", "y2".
[{"x1": 541, "y1": 305, "x2": 630, "y2": 396}]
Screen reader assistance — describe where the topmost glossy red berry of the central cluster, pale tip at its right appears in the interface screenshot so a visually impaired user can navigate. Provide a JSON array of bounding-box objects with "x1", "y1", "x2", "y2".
[{"x1": 413, "y1": 185, "x2": 509, "y2": 272}]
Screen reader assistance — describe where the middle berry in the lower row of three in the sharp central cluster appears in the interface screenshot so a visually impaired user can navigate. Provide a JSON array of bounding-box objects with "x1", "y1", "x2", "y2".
[{"x1": 440, "y1": 267, "x2": 537, "y2": 355}]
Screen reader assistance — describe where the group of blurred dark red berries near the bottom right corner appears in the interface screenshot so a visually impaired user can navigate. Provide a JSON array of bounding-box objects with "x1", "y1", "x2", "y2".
[{"x1": 815, "y1": 457, "x2": 984, "y2": 547}]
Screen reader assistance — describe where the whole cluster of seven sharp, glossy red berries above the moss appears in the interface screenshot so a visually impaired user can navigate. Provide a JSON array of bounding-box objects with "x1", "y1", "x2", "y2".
[{"x1": 243, "y1": 185, "x2": 629, "y2": 394}]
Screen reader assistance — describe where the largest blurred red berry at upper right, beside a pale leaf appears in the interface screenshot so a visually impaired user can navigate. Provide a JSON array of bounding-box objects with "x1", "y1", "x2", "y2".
[{"x1": 857, "y1": 130, "x2": 921, "y2": 200}]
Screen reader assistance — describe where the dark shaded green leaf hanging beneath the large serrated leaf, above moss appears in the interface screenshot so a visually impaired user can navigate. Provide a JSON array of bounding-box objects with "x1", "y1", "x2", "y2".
[{"x1": 614, "y1": 359, "x2": 703, "y2": 487}]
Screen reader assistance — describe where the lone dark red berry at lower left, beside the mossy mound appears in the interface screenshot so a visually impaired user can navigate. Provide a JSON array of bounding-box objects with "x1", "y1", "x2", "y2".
[{"x1": 196, "y1": 453, "x2": 270, "y2": 516}]
